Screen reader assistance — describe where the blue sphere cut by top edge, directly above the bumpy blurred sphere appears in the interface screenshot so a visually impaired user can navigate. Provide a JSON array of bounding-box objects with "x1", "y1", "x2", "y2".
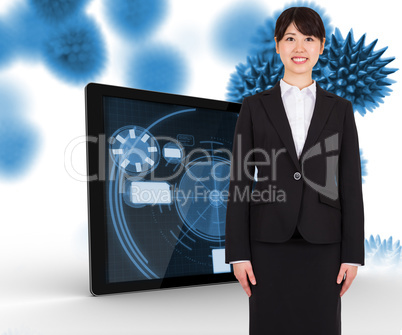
[{"x1": 29, "y1": 0, "x2": 88, "y2": 24}]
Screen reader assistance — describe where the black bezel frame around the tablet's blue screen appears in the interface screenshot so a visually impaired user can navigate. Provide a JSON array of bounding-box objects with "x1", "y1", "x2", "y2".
[{"x1": 85, "y1": 83, "x2": 241, "y2": 296}]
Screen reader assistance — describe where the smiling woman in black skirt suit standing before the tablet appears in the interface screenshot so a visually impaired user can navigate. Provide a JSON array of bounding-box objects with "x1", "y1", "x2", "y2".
[{"x1": 225, "y1": 7, "x2": 364, "y2": 335}]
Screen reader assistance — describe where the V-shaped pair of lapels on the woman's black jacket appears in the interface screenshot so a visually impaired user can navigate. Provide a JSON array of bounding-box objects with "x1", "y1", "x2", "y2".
[{"x1": 262, "y1": 81, "x2": 335, "y2": 171}]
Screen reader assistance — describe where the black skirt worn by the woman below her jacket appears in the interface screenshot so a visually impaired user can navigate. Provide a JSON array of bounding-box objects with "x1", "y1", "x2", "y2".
[{"x1": 249, "y1": 229, "x2": 342, "y2": 335}]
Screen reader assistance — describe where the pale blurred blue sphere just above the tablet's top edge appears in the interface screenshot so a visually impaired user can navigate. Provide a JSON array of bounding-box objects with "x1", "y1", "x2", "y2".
[{"x1": 127, "y1": 45, "x2": 188, "y2": 93}]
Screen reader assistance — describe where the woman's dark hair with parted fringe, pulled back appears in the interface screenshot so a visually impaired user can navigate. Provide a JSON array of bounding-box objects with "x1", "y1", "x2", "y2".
[{"x1": 275, "y1": 7, "x2": 325, "y2": 43}]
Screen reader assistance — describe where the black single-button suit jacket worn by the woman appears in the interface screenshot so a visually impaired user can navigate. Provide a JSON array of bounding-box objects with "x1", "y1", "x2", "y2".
[{"x1": 225, "y1": 81, "x2": 364, "y2": 265}]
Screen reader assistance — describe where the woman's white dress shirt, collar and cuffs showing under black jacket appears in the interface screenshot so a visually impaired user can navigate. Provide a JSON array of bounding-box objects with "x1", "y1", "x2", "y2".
[{"x1": 230, "y1": 79, "x2": 361, "y2": 266}]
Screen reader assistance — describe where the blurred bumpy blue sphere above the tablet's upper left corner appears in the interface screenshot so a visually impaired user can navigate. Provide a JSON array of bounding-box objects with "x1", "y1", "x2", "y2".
[{"x1": 42, "y1": 17, "x2": 106, "y2": 83}]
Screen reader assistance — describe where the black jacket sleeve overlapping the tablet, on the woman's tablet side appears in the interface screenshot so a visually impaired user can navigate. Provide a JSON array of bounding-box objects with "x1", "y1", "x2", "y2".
[{"x1": 225, "y1": 97, "x2": 255, "y2": 263}]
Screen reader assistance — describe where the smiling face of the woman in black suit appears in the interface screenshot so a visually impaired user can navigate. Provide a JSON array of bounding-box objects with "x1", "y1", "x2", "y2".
[{"x1": 275, "y1": 23, "x2": 325, "y2": 75}]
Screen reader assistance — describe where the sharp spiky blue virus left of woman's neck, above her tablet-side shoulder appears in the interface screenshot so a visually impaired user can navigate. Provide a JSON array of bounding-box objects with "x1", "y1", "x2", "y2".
[{"x1": 226, "y1": 54, "x2": 284, "y2": 103}]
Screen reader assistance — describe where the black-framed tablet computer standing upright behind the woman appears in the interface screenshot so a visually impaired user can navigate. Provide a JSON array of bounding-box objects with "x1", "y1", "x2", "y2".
[{"x1": 85, "y1": 83, "x2": 241, "y2": 295}]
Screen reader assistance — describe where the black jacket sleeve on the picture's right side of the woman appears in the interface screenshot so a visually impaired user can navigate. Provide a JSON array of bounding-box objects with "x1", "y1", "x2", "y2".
[{"x1": 339, "y1": 101, "x2": 364, "y2": 265}]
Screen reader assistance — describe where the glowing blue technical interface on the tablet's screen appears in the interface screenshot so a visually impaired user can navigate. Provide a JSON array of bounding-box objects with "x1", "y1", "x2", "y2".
[{"x1": 103, "y1": 97, "x2": 238, "y2": 283}]
